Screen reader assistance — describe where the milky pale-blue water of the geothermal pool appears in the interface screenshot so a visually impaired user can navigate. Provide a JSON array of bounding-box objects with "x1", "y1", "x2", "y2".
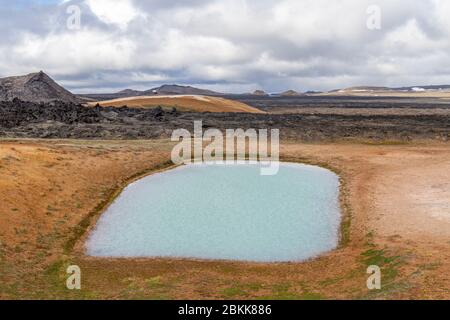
[{"x1": 87, "y1": 163, "x2": 340, "y2": 262}]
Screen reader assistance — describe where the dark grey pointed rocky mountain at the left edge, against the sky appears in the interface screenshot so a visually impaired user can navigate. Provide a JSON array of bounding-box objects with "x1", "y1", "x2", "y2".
[{"x1": 0, "y1": 71, "x2": 80, "y2": 103}]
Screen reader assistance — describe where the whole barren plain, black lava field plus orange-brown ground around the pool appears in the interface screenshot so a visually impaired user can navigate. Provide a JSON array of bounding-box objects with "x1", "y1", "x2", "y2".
[{"x1": 0, "y1": 97, "x2": 450, "y2": 299}]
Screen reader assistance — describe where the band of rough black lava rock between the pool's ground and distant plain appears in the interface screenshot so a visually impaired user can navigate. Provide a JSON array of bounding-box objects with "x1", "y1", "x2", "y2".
[{"x1": 0, "y1": 99, "x2": 450, "y2": 141}]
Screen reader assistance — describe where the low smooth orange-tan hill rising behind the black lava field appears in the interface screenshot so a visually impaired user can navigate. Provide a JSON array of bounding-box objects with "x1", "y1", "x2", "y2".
[{"x1": 89, "y1": 95, "x2": 265, "y2": 113}]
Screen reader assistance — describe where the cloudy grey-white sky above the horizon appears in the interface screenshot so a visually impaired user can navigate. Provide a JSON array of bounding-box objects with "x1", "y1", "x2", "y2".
[{"x1": 0, "y1": 0, "x2": 450, "y2": 93}]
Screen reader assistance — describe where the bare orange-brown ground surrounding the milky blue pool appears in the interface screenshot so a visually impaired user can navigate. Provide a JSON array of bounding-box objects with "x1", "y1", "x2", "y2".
[{"x1": 0, "y1": 141, "x2": 450, "y2": 299}]
